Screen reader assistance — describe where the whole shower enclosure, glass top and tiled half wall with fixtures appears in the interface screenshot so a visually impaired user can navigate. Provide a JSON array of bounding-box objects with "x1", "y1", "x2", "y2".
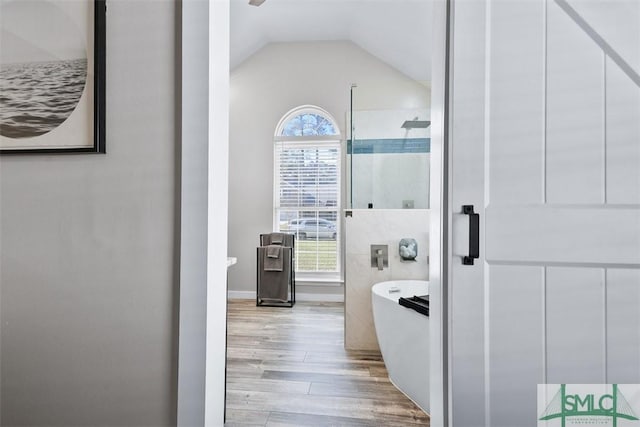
[{"x1": 342, "y1": 82, "x2": 431, "y2": 350}]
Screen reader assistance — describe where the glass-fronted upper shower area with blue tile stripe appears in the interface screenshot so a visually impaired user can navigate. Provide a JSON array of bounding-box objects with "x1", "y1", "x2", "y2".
[{"x1": 345, "y1": 82, "x2": 431, "y2": 209}]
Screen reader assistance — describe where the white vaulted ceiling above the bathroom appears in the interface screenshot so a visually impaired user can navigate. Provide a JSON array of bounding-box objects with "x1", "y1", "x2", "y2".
[{"x1": 231, "y1": 0, "x2": 432, "y2": 81}]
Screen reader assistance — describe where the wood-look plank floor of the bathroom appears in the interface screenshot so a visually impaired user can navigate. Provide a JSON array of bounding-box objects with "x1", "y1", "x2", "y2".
[{"x1": 225, "y1": 300, "x2": 429, "y2": 427}]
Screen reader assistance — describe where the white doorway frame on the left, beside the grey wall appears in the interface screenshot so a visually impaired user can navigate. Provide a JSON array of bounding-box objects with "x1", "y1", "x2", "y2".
[{"x1": 174, "y1": 0, "x2": 230, "y2": 426}]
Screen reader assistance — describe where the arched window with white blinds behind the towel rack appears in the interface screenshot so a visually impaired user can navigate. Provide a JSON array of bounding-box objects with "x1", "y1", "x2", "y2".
[{"x1": 274, "y1": 105, "x2": 341, "y2": 280}]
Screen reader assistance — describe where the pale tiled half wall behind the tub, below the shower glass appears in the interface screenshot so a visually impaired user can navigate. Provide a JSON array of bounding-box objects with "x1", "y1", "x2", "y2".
[{"x1": 344, "y1": 209, "x2": 429, "y2": 350}]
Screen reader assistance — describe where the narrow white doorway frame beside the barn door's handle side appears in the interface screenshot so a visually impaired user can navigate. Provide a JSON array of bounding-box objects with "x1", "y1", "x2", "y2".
[{"x1": 429, "y1": 0, "x2": 453, "y2": 427}]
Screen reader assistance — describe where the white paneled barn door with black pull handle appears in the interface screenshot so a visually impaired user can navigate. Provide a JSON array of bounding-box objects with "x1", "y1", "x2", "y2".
[{"x1": 448, "y1": 0, "x2": 640, "y2": 427}]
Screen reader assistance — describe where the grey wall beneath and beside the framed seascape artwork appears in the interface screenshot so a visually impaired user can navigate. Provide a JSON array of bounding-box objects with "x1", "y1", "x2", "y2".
[{"x1": 0, "y1": 0, "x2": 177, "y2": 426}]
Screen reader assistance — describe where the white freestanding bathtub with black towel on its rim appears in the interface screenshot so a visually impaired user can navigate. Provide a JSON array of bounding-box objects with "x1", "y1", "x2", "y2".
[{"x1": 371, "y1": 280, "x2": 429, "y2": 413}]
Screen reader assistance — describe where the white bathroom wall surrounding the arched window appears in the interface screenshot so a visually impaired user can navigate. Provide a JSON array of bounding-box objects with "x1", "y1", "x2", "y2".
[{"x1": 229, "y1": 41, "x2": 425, "y2": 296}]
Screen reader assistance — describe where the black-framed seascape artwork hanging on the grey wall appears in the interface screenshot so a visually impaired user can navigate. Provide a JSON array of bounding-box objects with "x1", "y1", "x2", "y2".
[{"x1": 0, "y1": 0, "x2": 106, "y2": 154}]
